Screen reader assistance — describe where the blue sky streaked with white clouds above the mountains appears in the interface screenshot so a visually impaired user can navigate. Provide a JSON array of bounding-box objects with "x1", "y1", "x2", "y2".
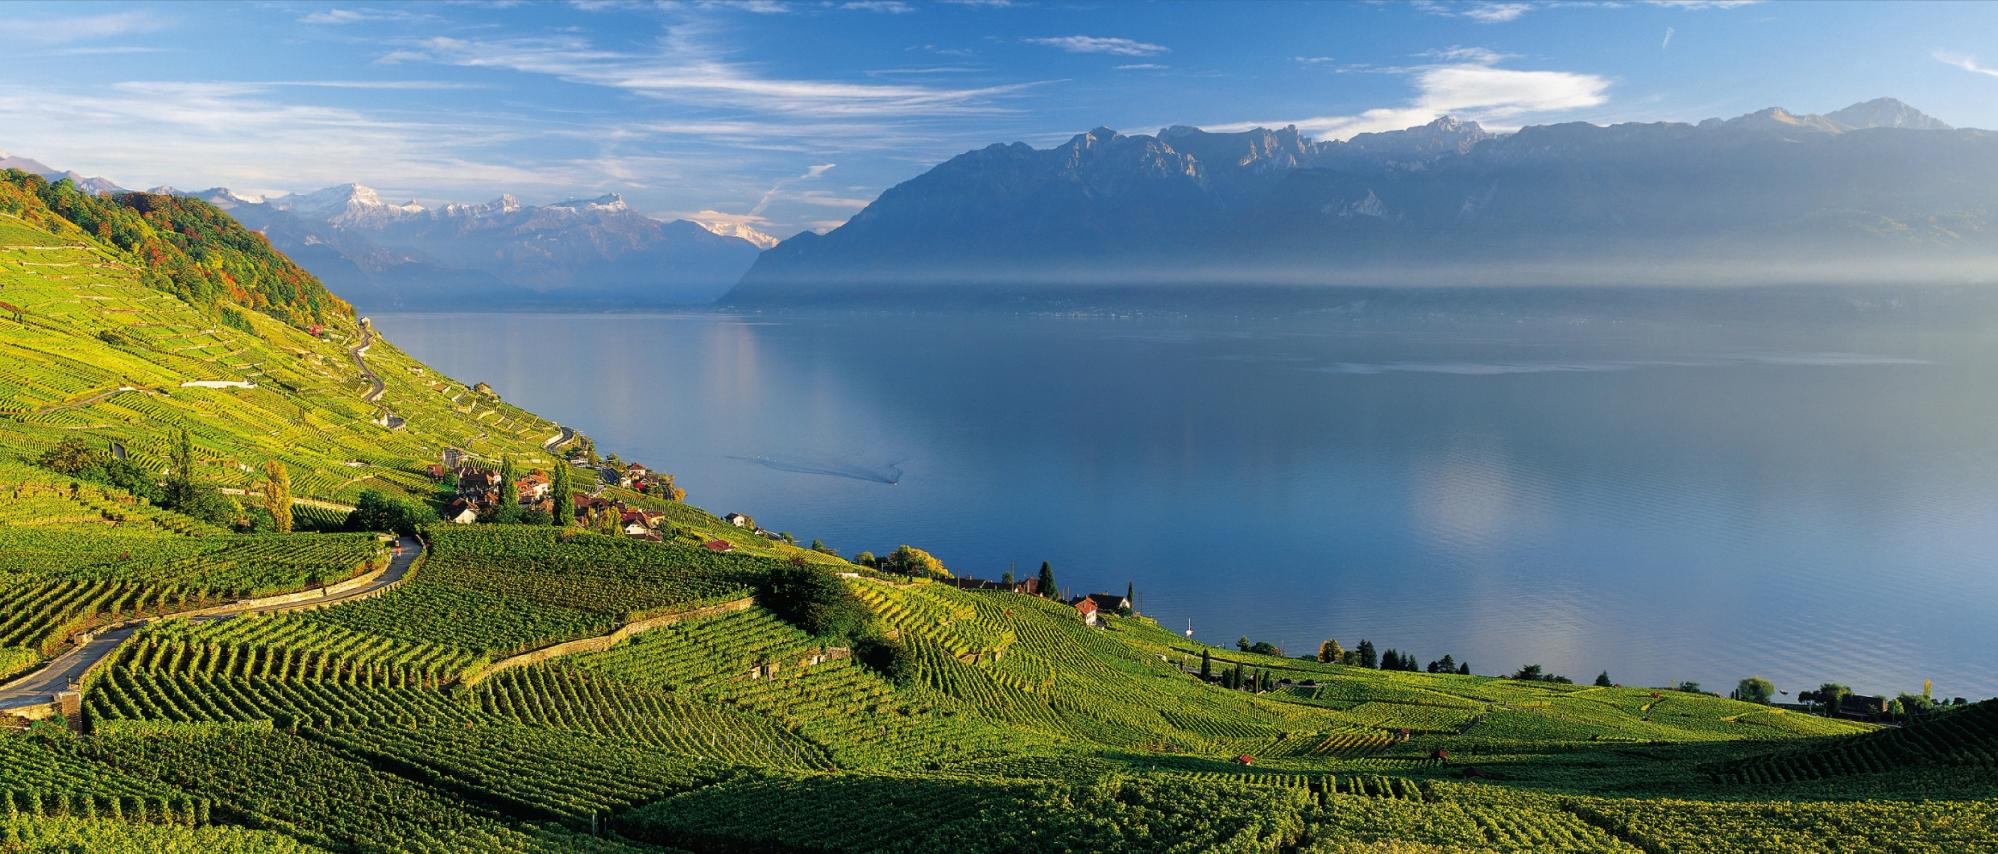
[{"x1": 0, "y1": 0, "x2": 1998, "y2": 236}]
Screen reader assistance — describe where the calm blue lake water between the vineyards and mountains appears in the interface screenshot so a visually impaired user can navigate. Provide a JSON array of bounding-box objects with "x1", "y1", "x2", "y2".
[{"x1": 376, "y1": 314, "x2": 1998, "y2": 698}]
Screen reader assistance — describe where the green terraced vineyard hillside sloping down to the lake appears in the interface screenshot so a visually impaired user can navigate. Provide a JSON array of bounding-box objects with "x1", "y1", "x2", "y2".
[{"x1": 0, "y1": 191, "x2": 1998, "y2": 852}]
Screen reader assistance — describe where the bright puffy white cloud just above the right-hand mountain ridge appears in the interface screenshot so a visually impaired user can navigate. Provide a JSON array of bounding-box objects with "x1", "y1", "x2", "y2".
[{"x1": 1207, "y1": 62, "x2": 1610, "y2": 140}]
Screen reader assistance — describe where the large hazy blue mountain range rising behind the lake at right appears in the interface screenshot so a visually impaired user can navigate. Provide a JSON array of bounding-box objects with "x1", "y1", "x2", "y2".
[{"x1": 725, "y1": 98, "x2": 1998, "y2": 304}]
